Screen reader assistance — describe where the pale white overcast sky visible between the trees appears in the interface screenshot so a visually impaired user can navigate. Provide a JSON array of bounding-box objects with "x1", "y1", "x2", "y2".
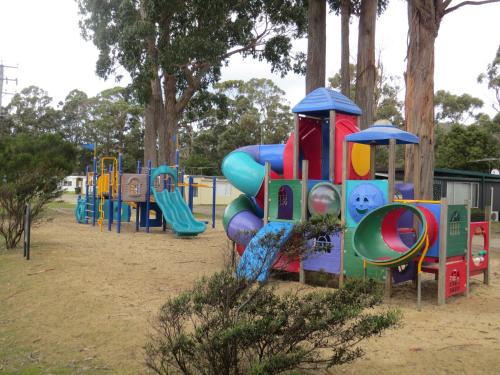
[{"x1": 0, "y1": 0, "x2": 500, "y2": 114}]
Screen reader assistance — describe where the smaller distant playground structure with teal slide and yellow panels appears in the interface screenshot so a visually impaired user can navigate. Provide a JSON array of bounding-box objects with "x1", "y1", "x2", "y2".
[{"x1": 75, "y1": 155, "x2": 217, "y2": 236}]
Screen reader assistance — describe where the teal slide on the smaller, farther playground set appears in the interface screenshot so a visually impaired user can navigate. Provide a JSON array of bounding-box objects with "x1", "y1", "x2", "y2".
[{"x1": 151, "y1": 165, "x2": 206, "y2": 236}]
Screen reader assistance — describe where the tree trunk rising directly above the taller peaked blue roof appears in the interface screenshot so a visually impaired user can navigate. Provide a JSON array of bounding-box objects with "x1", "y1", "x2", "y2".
[{"x1": 306, "y1": 0, "x2": 326, "y2": 94}]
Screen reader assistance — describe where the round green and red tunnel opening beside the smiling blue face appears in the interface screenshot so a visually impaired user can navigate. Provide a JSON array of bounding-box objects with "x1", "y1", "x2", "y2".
[{"x1": 353, "y1": 204, "x2": 437, "y2": 267}]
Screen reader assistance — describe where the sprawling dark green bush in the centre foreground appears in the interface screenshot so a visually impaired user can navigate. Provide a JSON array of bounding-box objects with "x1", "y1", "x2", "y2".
[{"x1": 145, "y1": 271, "x2": 399, "y2": 375}]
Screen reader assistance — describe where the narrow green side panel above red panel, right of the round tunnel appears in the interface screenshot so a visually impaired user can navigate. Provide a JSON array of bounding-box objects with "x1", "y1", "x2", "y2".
[{"x1": 446, "y1": 204, "x2": 468, "y2": 257}]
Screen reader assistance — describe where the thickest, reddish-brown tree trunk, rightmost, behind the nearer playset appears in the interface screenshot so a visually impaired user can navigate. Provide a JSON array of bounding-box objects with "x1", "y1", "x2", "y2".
[{"x1": 405, "y1": 0, "x2": 440, "y2": 199}]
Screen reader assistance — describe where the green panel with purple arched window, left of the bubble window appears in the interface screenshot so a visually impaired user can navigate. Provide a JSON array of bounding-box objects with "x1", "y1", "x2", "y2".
[{"x1": 267, "y1": 180, "x2": 302, "y2": 223}]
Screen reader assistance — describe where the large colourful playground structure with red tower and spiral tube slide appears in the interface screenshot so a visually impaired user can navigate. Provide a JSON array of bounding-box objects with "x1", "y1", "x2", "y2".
[{"x1": 222, "y1": 88, "x2": 489, "y2": 306}]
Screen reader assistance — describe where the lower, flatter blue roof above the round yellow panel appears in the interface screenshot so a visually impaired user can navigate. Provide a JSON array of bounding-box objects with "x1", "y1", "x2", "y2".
[{"x1": 345, "y1": 124, "x2": 420, "y2": 145}]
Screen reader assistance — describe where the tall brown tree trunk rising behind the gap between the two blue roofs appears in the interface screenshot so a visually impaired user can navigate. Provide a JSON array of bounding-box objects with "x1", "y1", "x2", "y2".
[{"x1": 356, "y1": 0, "x2": 377, "y2": 129}]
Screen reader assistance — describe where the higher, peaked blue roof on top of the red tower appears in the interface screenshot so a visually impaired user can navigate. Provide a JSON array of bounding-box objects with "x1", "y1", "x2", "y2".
[{"x1": 292, "y1": 87, "x2": 361, "y2": 117}]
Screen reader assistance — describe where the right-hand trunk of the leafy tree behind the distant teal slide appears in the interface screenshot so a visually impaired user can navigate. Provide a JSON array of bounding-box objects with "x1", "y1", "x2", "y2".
[{"x1": 158, "y1": 75, "x2": 179, "y2": 166}]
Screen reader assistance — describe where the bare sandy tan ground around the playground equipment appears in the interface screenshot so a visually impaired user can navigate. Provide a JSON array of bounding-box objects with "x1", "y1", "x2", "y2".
[{"x1": 0, "y1": 209, "x2": 500, "y2": 374}]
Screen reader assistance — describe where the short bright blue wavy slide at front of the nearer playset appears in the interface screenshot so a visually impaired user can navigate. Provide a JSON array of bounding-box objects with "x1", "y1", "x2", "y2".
[{"x1": 236, "y1": 221, "x2": 294, "y2": 282}]
